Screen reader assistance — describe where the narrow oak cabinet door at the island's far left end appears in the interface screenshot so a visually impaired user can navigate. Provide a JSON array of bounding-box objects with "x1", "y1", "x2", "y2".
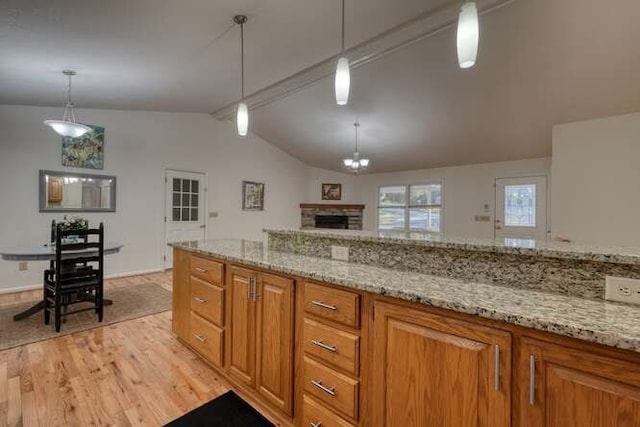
[{"x1": 171, "y1": 249, "x2": 191, "y2": 341}]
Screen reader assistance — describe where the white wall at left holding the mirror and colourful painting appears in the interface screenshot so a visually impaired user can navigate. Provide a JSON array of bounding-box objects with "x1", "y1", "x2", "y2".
[{"x1": 0, "y1": 106, "x2": 308, "y2": 291}]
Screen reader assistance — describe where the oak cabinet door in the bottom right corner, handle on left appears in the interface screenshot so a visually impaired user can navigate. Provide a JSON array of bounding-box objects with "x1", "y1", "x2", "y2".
[{"x1": 517, "y1": 338, "x2": 640, "y2": 427}]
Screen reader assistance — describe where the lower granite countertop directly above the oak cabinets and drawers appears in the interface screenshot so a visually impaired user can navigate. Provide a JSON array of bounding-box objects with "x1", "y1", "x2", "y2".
[{"x1": 170, "y1": 240, "x2": 640, "y2": 352}]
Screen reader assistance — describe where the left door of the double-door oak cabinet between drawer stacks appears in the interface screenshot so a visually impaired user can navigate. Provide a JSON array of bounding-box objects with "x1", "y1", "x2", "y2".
[{"x1": 226, "y1": 266, "x2": 257, "y2": 387}]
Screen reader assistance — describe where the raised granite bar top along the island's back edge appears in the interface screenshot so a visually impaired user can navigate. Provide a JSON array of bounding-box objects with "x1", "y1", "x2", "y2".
[{"x1": 263, "y1": 229, "x2": 640, "y2": 265}]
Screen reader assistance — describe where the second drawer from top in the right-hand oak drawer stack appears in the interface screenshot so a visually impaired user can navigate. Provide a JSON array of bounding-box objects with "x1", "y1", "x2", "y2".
[{"x1": 303, "y1": 318, "x2": 360, "y2": 376}]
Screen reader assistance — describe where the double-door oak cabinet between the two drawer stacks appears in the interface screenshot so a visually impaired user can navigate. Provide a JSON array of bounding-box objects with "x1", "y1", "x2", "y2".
[{"x1": 227, "y1": 267, "x2": 294, "y2": 415}]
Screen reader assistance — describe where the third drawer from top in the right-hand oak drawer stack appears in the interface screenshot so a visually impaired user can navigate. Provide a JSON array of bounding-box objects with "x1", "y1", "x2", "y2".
[{"x1": 304, "y1": 357, "x2": 359, "y2": 419}]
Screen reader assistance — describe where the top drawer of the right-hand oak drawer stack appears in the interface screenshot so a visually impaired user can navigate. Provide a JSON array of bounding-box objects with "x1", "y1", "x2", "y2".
[{"x1": 304, "y1": 282, "x2": 360, "y2": 328}]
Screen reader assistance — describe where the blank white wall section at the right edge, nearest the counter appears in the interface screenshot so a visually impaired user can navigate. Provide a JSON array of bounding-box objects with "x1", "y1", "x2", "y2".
[{"x1": 551, "y1": 113, "x2": 640, "y2": 247}]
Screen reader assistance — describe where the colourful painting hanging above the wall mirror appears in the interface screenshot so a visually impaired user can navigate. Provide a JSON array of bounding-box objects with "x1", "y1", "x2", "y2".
[{"x1": 62, "y1": 125, "x2": 104, "y2": 169}]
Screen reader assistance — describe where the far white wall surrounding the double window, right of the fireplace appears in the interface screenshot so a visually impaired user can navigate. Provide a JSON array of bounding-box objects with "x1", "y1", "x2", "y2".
[{"x1": 356, "y1": 157, "x2": 551, "y2": 238}]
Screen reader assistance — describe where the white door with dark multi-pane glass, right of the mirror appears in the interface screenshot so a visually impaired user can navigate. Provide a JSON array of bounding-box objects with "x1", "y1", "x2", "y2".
[{"x1": 164, "y1": 169, "x2": 206, "y2": 268}]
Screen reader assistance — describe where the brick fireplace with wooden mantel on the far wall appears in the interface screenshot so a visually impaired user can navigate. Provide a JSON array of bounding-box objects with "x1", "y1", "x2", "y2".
[{"x1": 300, "y1": 203, "x2": 364, "y2": 230}]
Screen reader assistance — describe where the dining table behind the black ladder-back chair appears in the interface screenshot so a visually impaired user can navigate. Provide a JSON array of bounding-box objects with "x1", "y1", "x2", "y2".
[{"x1": 0, "y1": 242, "x2": 124, "y2": 321}]
